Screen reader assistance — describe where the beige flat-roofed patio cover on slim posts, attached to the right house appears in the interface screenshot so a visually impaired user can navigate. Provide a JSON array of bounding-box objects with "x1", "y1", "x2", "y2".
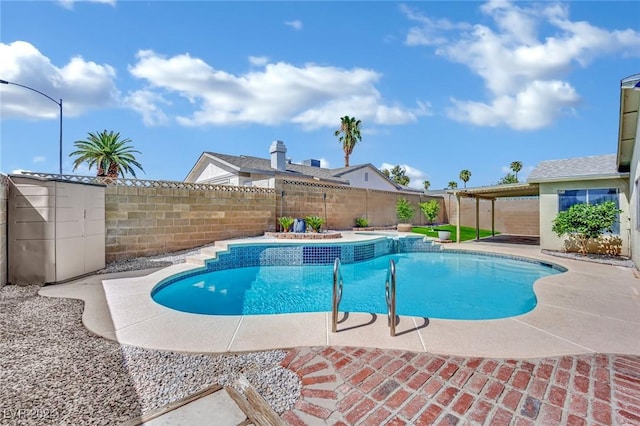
[{"x1": 447, "y1": 183, "x2": 540, "y2": 241}]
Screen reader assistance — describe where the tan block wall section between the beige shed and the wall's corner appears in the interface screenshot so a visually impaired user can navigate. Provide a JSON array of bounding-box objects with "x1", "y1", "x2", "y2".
[{"x1": 105, "y1": 186, "x2": 276, "y2": 262}]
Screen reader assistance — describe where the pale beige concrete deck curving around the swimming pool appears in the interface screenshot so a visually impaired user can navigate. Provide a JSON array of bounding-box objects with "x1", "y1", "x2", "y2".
[{"x1": 40, "y1": 232, "x2": 640, "y2": 358}]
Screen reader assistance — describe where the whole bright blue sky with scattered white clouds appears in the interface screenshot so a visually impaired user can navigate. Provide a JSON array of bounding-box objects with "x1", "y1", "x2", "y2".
[{"x1": 0, "y1": 0, "x2": 640, "y2": 189}]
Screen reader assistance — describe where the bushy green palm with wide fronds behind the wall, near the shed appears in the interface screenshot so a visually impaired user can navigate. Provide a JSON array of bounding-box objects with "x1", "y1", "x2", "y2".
[{"x1": 69, "y1": 130, "x2": 144, "y2": 178}]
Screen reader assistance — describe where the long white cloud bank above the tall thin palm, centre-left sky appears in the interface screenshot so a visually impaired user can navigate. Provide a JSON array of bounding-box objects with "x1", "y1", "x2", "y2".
[{"x1": 129, "y1": 51, "x2": 430, "y2": 129}]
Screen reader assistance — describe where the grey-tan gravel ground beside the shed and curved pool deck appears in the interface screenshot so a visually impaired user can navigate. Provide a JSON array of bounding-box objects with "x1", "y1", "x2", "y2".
[{"x1": 0, "y1": 285, "x2": 301, "y2": 425}]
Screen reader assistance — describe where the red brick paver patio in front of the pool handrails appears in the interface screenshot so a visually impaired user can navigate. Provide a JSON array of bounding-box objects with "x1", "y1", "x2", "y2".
[{"x1": 282, "y1": 347, "x2": 640, "y2": 426}]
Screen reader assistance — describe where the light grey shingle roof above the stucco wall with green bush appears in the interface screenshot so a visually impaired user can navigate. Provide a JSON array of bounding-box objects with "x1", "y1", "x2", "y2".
[{"x1": 527, "y1": 154, "x2": 627, "y2": 183}]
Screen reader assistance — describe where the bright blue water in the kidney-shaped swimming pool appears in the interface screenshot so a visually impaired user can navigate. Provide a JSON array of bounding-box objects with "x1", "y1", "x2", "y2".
[{"x1": 152, "y1": 252, "x2": 561, "y2": 320}]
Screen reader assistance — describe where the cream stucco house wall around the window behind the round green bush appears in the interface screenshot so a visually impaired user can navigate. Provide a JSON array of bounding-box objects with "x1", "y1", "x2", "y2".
[{"x1": 540, "y1": 178, "x2": 630, "y2": 256}]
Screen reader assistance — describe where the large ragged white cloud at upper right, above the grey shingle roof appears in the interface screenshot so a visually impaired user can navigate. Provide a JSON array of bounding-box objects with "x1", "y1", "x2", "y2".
[{"x1": 402, "y1": 0, "x2": 640, "y2": 130}]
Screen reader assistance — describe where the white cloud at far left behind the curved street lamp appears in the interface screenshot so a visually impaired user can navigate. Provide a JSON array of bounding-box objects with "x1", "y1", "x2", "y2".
[{"x1": 0, "y1": 41, "x2": 119, "y2": 118}]
